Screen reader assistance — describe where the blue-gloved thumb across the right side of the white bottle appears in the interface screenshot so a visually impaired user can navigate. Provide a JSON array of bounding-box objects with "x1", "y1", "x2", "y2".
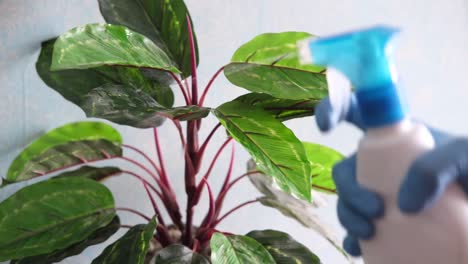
[{"x1": 398, "y1": 138, "x2": 468, "y2": 213}]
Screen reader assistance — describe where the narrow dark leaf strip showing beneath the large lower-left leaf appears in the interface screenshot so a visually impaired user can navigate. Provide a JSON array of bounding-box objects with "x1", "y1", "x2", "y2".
[{"x1": 11, "y1": 216, "x2": 120, "y2": 264}]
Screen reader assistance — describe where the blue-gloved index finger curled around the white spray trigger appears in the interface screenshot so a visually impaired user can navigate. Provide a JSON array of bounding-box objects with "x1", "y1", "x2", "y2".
[{"x1": 315, "y1": 94, "x2": 364, "y2": 132}]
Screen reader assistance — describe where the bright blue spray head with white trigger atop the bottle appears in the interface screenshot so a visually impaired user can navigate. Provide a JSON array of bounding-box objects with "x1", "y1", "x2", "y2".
[{"x1": 298, "y1": 26, "x2": 404, "y2": 126}]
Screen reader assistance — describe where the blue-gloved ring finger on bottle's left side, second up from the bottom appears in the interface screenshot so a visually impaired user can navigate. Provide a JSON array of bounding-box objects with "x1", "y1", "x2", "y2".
[{"x1": 338, "y1": 199, "x2": 375, "y2": 239}]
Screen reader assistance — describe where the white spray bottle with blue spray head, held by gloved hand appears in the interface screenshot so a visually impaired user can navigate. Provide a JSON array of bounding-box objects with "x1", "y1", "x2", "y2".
[{"x1": 299, "y1": 26, "x2": 468, "y2": 264}]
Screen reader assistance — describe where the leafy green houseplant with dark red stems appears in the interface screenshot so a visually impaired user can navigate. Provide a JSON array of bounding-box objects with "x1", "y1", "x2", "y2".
[{"x1": 0, "y1": 0, "x2": 350, "y2": 263}]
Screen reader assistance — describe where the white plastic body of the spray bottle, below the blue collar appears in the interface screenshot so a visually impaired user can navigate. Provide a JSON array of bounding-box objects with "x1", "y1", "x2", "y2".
[{"x1": 357, "y1": 120, "x2": 468, "y2": 264}]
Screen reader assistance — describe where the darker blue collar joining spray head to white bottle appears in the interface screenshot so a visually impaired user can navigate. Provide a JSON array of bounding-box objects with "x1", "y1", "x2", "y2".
[{"x1": 356, "y1": 83, "x2": 406, "y2": 128}]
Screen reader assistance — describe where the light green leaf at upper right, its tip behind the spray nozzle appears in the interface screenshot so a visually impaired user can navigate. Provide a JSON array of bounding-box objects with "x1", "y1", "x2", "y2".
[{"x1": 224, "y1": 32, "x2": 327, "y2": 100}]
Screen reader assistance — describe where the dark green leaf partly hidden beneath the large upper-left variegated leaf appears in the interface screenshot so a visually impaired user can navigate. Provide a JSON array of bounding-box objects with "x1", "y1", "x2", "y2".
[{"x1": 36, "y1": 39, "x2": 174, "y2": 107}]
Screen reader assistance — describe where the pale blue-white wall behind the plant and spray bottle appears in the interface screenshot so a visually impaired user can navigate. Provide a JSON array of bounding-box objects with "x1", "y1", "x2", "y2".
[{"x1": 0, "y1": 0, "x2": 468, "y2": 264}]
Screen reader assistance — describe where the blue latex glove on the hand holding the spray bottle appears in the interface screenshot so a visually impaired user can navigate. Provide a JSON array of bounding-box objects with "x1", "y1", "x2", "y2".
[{"x1": 316, "y1": 96, "x2": 458, "y2": 256}]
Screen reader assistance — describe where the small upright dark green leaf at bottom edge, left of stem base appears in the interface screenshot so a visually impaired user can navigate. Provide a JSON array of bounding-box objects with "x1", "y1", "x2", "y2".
[{"x1": 92, "y1": 217, "x2": 157, "y2": 264}]
